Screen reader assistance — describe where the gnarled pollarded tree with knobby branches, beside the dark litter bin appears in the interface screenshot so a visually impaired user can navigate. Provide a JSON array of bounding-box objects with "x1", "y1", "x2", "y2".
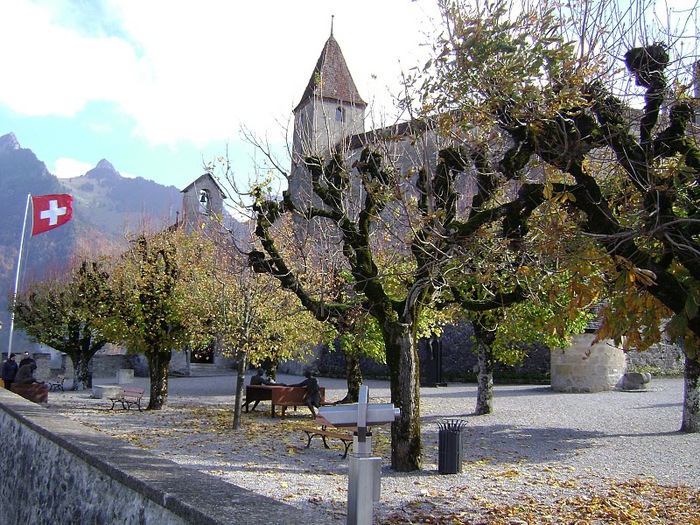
[{"x1": 249, "y1": 138, "x2": 560, "y2": 471}]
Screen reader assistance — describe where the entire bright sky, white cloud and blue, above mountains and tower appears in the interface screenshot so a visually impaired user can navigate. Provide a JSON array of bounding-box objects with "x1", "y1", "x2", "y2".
[{"x1": 0, "y1": 0, "x2": 437, "y2": 189}]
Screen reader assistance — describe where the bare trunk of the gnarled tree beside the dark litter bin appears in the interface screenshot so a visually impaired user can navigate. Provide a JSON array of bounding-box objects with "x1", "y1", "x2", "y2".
[{"x1": 382, "y1": 322, "x2": 423, "y2": 472}]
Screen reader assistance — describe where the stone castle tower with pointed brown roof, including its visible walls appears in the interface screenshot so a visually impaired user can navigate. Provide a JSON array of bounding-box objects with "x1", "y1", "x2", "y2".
[{"x1": 289, "y1": 25, "x2": 367, "y2": 202}]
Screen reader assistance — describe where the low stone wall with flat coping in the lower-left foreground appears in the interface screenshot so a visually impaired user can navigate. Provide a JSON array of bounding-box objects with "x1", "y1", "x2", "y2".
[{"x1": 0, "y1": 389, "x2": 330, "y2": 525}]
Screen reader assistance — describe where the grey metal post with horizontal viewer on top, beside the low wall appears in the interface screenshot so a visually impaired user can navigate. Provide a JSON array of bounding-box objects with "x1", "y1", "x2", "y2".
[{"x1": 318, "y1": 385, "x2": 401, "y2": 525}]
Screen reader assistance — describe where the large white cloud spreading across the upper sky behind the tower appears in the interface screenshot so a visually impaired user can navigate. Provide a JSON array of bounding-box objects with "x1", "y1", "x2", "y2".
[{"x1": 0, "y1": 0, "x2": 436, "y2": 146}]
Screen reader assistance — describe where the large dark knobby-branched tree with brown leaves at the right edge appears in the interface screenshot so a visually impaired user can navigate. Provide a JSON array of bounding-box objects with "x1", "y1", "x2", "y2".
[{"x1": 423, "y1": 1, "x2": 700, "y2": 432}]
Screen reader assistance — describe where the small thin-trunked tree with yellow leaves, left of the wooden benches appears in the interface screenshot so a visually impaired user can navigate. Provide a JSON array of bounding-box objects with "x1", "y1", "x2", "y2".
[{"x1": 180, "y1": 225, "x2": 321, "y2": 429}]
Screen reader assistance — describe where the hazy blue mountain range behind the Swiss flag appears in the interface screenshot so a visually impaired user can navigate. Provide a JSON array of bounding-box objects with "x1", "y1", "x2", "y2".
[{"x1": 0, "y1": 133, "x2": 183, "y2": 340}]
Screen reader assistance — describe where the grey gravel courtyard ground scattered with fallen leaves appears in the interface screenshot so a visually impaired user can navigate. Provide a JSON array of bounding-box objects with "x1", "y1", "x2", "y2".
[{"x1": 48, "y1": 375, "x2": 700, "y2": 524}]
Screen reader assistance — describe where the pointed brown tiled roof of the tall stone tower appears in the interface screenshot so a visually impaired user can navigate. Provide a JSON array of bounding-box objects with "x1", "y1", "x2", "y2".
[{"x1": 294, "y1": 33, "x2": 367, "y2": 113}]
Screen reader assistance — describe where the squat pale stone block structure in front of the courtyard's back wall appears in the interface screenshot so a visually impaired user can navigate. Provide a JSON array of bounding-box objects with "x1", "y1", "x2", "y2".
[{"x1": 551, "y1": 333, "x2": 627, "y2": 392}]
